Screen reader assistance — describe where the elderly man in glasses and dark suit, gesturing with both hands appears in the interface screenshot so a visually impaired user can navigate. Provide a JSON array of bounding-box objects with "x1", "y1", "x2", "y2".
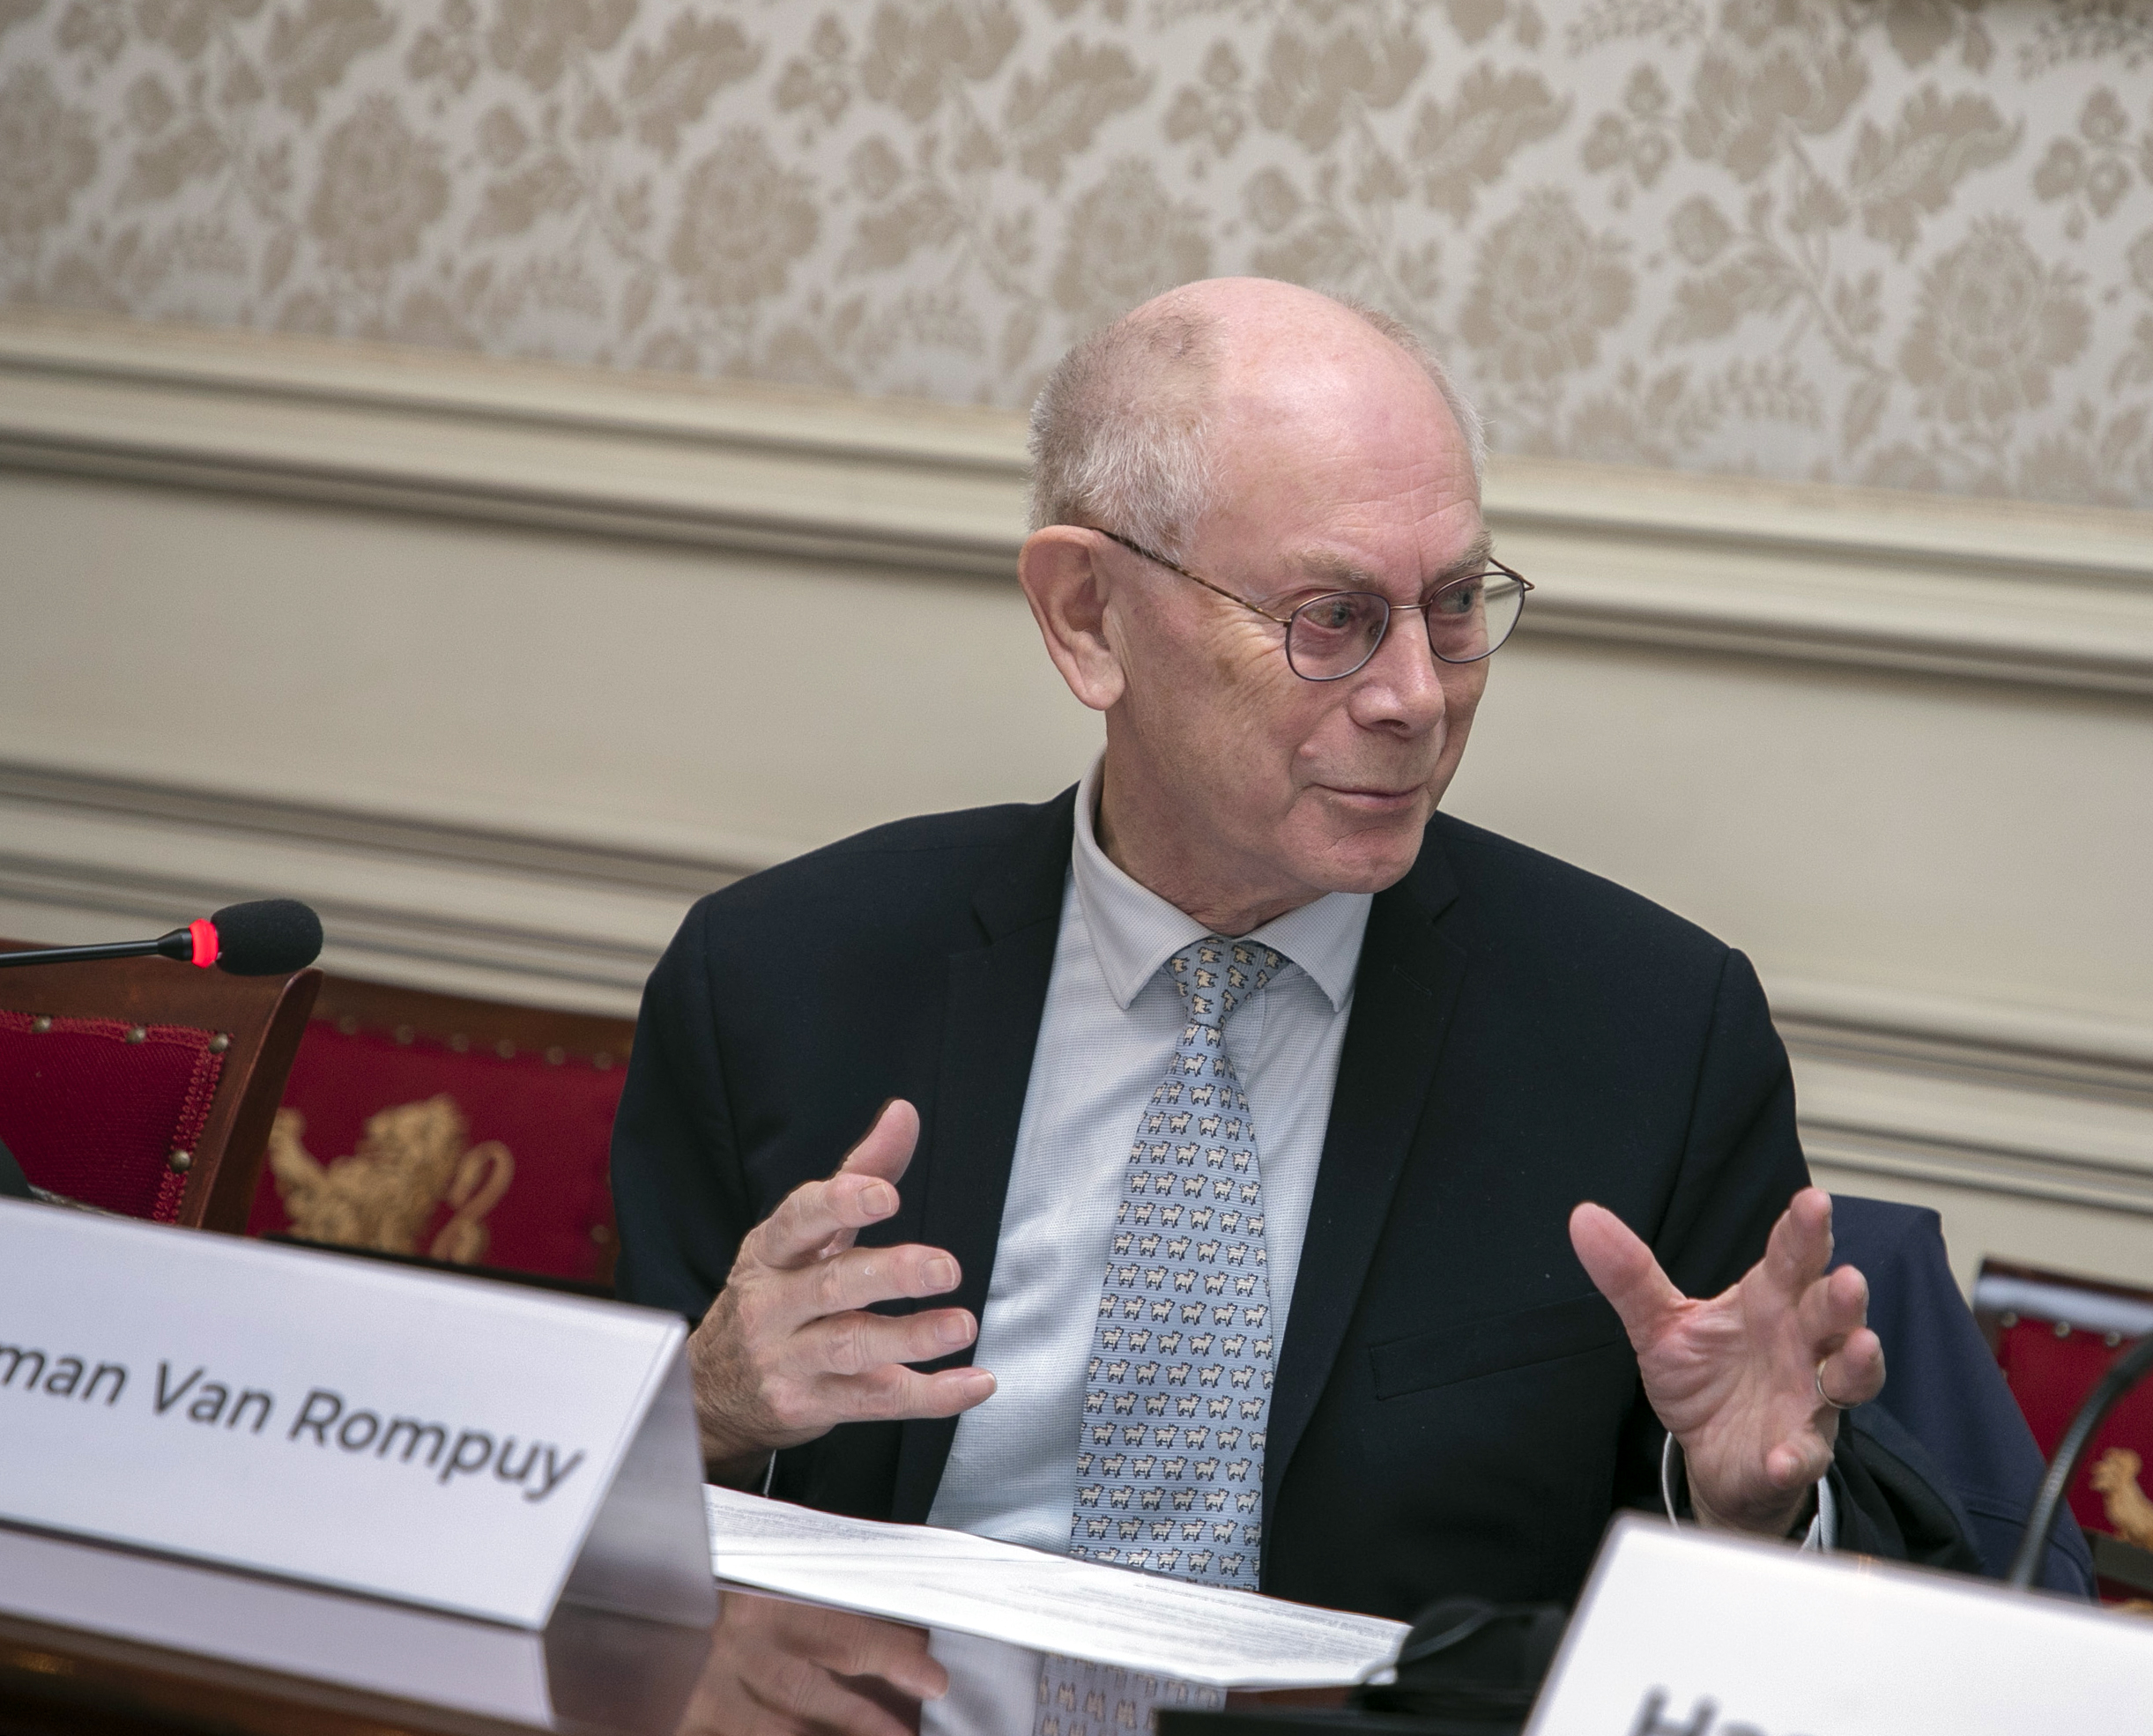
[{"x1": 613, "y1": 280, "x2": 1937, "y2": 1645}]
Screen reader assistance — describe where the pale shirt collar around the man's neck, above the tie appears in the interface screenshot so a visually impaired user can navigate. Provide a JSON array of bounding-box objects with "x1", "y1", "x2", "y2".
[{"x1": 1070, "y1": 753, "x2": 1374, "y2": 1013}]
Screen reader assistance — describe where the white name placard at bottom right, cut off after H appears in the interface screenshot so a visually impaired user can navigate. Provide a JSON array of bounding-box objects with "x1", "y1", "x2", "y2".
[{"x1": 1526, "y1": 1517, "x2": 2153, "y2": 1736}]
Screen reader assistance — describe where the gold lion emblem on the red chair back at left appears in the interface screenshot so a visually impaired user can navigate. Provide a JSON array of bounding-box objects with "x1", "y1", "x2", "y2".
[{"x1": 269, "y1": 1092, "x2": 516, "y2": 1266}]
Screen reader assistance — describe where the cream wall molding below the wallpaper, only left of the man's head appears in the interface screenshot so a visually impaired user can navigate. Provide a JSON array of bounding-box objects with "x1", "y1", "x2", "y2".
[{"x1": 0, "y1": 310, "x2": 1025, "y2": 575}]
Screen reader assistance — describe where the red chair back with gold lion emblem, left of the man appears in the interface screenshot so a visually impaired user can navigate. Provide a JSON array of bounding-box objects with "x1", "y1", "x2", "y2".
[{"x1": 248, "y1": 976, "x2": 635, "y2": 1288}]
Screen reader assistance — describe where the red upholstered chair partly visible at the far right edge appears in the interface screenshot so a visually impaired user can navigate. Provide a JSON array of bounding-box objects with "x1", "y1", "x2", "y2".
[{"x1": 1974, "y1": 1260, "x2": 2153, "y2": 1600}]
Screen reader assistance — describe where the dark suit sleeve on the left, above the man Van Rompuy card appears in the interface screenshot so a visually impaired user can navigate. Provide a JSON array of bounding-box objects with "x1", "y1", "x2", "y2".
[{"x1": 612, "y1": 901, "x2": 754, "y2": 1320}]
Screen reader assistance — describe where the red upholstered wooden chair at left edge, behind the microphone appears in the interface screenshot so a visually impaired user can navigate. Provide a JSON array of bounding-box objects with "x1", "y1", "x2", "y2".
[{"x1": 0, "y1": 941, "x2": 321, "y2": 1230}]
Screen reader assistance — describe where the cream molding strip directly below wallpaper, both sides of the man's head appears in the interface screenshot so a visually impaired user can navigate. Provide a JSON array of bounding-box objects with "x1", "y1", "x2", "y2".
[{"x1": 12, "y1": 308, "x2": 2153, "y2": 695}]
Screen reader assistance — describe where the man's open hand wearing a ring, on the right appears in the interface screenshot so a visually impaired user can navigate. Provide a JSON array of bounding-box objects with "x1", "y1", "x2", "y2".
[{"x1": 1570, "y1": 1187, "x2": 1884, "y2": 1538}]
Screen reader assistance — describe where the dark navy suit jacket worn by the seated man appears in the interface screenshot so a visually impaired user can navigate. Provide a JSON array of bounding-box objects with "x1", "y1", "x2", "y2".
[{"x1": 613, "y1": 792, "x2": 1964, "y2": 1618}]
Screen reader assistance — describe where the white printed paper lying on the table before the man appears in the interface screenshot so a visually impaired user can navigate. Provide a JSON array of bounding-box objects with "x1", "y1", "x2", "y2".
[{"x1": 704, "y1": 1488, "x2": 1406, "y2": 1688}]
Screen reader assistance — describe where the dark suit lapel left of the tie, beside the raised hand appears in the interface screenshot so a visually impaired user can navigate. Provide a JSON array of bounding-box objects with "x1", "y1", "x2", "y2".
[{"x1": 891, "y1": 790, "x2": 1077, "y2": 1525}]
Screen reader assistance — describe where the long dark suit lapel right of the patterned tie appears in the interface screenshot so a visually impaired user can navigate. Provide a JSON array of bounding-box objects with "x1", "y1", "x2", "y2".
[{"x1": 1264, "y1": 835, "x2": 1466, "y2": 1512}]
